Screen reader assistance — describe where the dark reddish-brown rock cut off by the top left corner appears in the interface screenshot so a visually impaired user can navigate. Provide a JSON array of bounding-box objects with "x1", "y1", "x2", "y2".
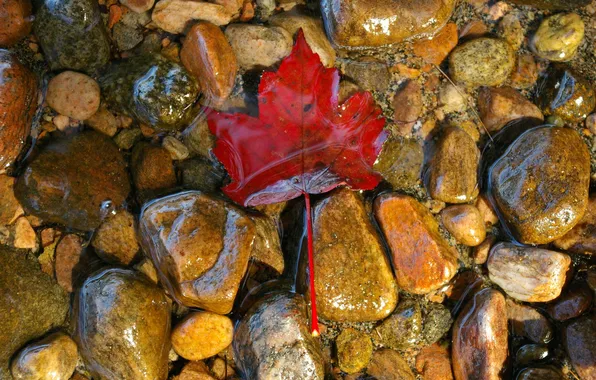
[{"x1": 0, "y1": 0, "x2": 33, "y2": 46}]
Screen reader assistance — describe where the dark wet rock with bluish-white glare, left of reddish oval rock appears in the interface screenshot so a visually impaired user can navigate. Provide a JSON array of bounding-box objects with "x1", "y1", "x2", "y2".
[{"x1": 99, "y1": 55, "x2": 199, "y2": 130}]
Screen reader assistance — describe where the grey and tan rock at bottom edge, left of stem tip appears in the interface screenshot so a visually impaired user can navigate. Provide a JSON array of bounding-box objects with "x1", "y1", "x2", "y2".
[{"x1": 233, "y1": 293, "x2": 325, "y2": 380}]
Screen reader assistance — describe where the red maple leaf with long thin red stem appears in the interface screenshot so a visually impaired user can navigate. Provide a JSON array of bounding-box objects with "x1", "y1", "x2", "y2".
[{"x1": 208, "y1": 30, "x2": 387, "y2": 334}]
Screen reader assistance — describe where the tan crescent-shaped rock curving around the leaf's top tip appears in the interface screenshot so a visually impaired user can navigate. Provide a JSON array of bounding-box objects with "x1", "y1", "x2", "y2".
[{"x1": 269, "y1": 6, "x2": 336, "y2": 67}]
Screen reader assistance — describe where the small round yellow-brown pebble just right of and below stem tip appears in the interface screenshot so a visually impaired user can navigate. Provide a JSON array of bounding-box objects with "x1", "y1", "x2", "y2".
[{"x1": 335, "y1": 328, "x2": 373, "y2": 374}]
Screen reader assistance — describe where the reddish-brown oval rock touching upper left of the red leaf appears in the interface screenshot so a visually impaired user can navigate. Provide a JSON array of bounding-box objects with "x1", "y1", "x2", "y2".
[{"x1": 180, "y1": 22, "x2": 238, "y2": 104}]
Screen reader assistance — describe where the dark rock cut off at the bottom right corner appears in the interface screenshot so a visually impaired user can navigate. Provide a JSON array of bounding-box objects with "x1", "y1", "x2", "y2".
[{"x1": 563, "y1": 315, "x2": 596, "y2": 379}]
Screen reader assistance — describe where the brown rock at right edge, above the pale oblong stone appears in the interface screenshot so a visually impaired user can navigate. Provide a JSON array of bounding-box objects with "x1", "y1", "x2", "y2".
[{"x1": 553, "y1": 197, "x2": 596, "y2": 255}]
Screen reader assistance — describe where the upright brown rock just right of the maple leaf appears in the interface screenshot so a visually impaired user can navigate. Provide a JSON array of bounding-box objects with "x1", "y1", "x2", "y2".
[{"x1": 426, "y1": 127, "x2": 480, "y2": 203}]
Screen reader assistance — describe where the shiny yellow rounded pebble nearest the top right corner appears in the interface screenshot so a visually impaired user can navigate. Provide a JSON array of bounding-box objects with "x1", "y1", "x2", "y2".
[{"x1": 530, "y1": 13, "x2": 585, "y2": 61}]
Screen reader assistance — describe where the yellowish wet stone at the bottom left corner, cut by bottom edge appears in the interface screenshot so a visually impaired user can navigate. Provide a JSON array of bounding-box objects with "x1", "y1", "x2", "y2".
[{"x1": 10, "y1": 333, "x2": 79, "y2": 380}]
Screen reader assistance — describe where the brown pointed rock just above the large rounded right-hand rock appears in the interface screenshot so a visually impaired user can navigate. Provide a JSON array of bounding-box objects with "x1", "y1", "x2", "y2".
[{"x1": 478, "y1": 87, "x2": 544, "y2": 132}]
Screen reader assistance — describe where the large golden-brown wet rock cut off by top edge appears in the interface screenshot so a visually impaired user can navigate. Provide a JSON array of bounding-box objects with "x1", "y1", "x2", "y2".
[{"x1": 321, "y1": 0, "x2": 455, "y2": 48}]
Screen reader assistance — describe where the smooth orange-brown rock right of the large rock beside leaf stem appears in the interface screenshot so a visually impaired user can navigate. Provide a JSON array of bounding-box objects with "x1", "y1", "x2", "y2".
[{"x1": 374, "y1": 194, "x2": 458, "y2": 294}]
